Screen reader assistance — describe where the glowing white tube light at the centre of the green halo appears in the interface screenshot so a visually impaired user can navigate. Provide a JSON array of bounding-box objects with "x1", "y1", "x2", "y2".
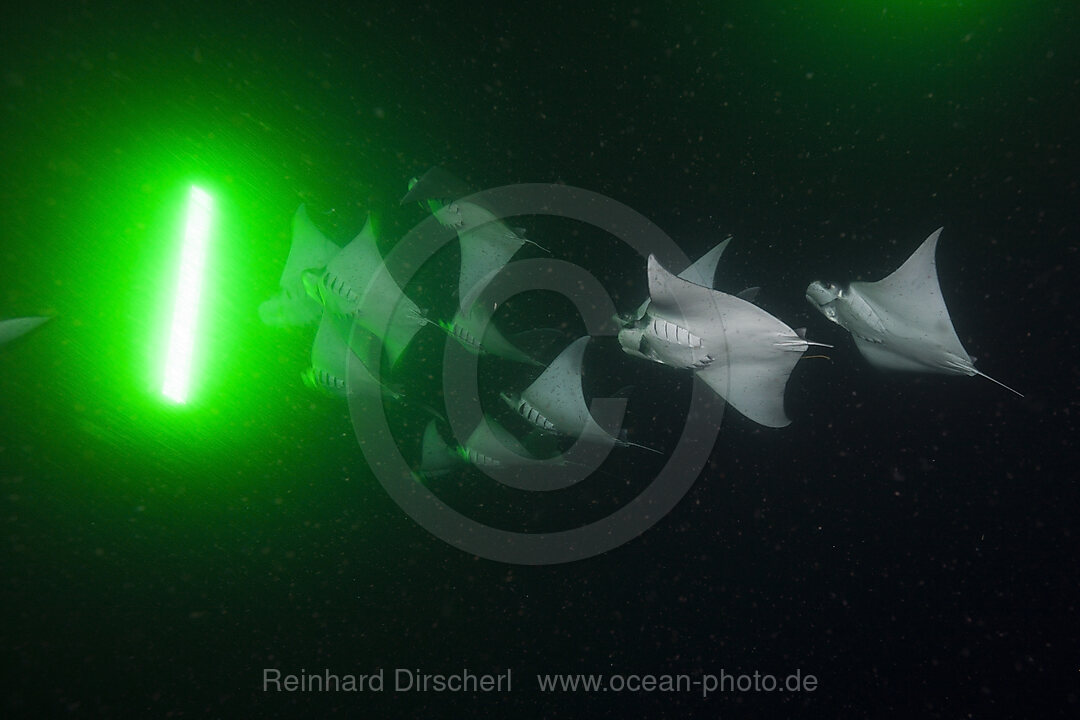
[{"x1": 161, "y1": 186, "x2": 213, "y2": 404}]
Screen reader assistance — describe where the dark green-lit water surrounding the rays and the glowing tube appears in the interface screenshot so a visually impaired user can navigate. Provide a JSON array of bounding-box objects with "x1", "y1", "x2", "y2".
[{"x1": 0, "y1": 2, "x2": 1080, "y2": 718}]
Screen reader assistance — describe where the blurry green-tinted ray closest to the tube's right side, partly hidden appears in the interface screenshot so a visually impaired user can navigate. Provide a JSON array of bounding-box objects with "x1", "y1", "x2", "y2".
[{"x1": 259, "y1": 205, "x2": 341, "y2": 326}]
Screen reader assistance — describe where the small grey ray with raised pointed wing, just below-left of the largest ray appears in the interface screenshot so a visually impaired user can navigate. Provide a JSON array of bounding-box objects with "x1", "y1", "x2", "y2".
[{"x1": 504, "y1": 336, "x2": 617, "y2": 443}]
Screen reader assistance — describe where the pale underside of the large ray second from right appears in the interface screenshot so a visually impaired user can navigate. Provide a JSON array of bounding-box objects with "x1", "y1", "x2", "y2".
[{"x1": 646, "y1": 256, "x2": 809, "y2": 427}]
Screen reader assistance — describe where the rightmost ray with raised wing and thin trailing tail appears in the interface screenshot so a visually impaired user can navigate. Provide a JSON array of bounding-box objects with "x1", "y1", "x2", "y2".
[{"x1": 807, "y1": 228, "x2": 1023, "y2": 397}]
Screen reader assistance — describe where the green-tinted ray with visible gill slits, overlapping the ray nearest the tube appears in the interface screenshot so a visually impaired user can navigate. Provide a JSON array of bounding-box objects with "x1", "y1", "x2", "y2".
[{"x1": 307, "y1": 212, "x2": 426, "y2": 365}]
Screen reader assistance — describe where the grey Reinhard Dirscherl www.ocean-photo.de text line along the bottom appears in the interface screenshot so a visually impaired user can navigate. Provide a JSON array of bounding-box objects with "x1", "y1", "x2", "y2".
[{"x1": 262, "y1": 667, "x2": 818, "y2": 696}]
